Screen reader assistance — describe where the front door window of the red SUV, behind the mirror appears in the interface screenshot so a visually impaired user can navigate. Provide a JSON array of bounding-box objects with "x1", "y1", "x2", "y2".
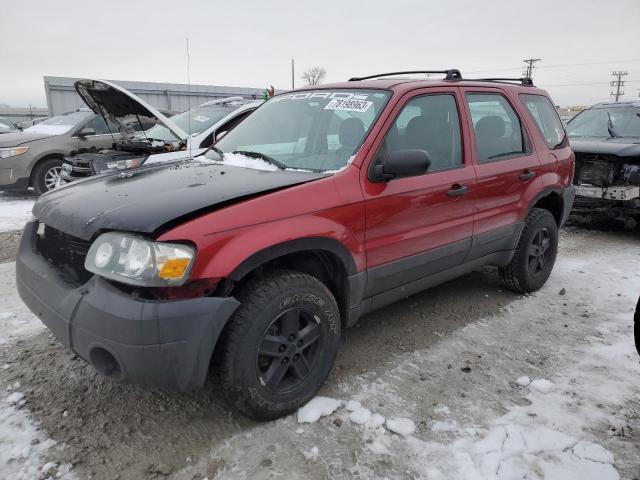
[{"x1": 377, "y1": 94, "x2": 462, "y2": 172}]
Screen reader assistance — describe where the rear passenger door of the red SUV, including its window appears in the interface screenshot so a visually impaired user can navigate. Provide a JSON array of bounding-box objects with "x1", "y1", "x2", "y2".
[{"x1": 462, "y1": 87, "x2": 542, "y2": 260}]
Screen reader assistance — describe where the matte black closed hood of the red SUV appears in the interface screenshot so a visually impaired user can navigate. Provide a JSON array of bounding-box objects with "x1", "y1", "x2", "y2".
[{"x1": 33, "y1": 160, "x2": 326, "y2": 240}]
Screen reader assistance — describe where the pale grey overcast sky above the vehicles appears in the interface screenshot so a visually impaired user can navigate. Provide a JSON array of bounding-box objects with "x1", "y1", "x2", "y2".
[{"x1": 0, "y1": 0, "x2": 640, "y2": 106}]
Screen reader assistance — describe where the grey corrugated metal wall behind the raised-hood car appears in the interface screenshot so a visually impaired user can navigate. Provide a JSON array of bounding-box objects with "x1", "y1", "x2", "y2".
[{"x1": 44, "y1": 77, "x2": 264, "y2": 115}]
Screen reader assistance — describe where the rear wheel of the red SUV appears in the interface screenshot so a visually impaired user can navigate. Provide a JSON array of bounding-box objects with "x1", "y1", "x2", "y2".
[{"x1": 498, "y1": 208, "x2": 558, "y2": 293}]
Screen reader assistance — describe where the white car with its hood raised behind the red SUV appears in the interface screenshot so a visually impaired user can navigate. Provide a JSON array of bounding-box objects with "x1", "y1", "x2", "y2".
[{"x1": 62, "y1": 80, "x2": 262, "y2": 182}]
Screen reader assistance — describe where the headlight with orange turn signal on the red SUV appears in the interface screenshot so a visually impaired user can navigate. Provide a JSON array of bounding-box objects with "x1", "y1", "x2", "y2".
[{"x1": 84, "y1": 232, "x2": 195, "y2": 287}]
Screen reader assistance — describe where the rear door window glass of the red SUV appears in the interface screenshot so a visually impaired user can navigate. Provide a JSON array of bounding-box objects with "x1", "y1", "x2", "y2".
[{"x1": 467, "y1": 93, "x2": 528, "y2": 163}]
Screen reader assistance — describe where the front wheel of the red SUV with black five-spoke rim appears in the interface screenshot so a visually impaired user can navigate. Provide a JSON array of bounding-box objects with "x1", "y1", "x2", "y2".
[{"x1": 212, "y1": 270, "x2": 340, "y2": 420}]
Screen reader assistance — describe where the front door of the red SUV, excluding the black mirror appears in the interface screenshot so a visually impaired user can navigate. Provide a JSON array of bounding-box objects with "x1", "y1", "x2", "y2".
[{"x1": 361, "y1": 88, "x2": 475, "y2": 296}]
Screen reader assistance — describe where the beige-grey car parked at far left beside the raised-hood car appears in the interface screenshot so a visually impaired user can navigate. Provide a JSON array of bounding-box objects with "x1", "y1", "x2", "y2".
[{"x1": 0, "y1": 105, "x2": 175, "y2": 194}]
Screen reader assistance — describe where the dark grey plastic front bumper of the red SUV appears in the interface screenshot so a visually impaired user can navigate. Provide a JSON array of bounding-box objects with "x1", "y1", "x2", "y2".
[{"x1": 16, "y1": 221, "x2": 239, "y2": 391}]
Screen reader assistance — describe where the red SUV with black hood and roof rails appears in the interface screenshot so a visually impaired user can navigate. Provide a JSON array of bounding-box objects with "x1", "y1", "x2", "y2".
[{"x1": 17, "y1": 70, "x2": 574, "y2": 419}]
